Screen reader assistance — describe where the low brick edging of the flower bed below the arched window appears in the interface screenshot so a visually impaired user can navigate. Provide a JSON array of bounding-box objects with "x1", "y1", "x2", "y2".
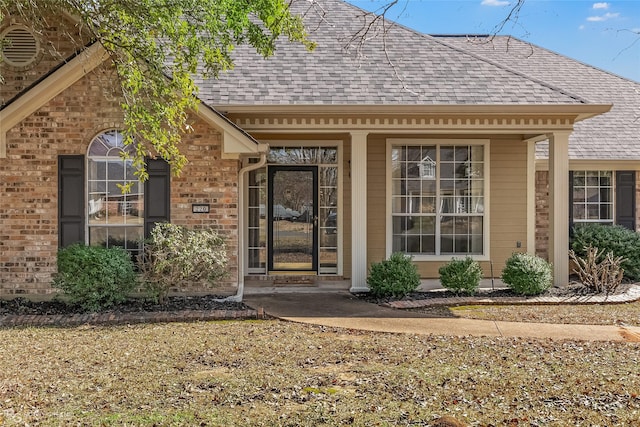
[{"x1": 0, "y1": 309, "x2": 264, "y2": 328}]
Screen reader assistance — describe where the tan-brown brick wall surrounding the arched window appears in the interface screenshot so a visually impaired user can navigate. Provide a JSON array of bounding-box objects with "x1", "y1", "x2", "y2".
[{"x1": 0, "y1": 67, "x2": 239, "y2": 295}]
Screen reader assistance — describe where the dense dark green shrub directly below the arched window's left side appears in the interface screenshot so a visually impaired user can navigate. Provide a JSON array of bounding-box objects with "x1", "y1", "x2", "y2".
[{"x1": 53, "y1": 244, "x2": 137, "y2": 311}]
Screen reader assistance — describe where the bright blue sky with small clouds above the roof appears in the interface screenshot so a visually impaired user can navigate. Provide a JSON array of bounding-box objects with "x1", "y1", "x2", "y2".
[{"x1": 347, "y1": 0, "x2": 640, "y2": 82}]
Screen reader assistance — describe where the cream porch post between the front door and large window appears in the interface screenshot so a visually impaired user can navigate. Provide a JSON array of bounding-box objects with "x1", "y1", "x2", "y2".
[{"x1": 350, "y1": 131, "x2": 369, "y2": 292}]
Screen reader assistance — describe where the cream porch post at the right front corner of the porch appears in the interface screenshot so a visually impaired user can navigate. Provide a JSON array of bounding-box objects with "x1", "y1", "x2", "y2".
[{"x1": 548, "y1": 132, "x2": 571, "y2": 286}]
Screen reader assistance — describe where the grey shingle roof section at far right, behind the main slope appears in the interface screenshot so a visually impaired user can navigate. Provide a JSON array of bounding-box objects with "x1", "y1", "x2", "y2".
[{"x1": 436, "y1": 36, "x2": 640, "y2": 160}]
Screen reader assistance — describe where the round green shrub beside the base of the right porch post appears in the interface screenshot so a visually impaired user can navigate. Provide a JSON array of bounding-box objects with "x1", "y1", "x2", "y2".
[{"x1": 502, "y1": 253, "x2": 553, "y2": 295}]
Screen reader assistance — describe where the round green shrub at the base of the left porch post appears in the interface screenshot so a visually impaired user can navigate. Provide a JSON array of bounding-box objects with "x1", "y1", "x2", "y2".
[{"x1": 367, "y1": 252, "x2": 420, "y2": 298}]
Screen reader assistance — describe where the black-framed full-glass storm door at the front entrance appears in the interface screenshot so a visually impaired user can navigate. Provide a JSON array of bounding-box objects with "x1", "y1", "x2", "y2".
[{"x1": 267, "y1": 166, "x2": 318, "y2": 273}]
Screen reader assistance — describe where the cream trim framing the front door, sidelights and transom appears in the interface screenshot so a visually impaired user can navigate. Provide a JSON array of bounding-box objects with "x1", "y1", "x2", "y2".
[{"x1": 246, "y1": 139, "x2": 344, "y2": 277}]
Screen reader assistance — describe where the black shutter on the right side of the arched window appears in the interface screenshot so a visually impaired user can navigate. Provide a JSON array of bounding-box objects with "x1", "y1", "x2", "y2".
[{"x1": 144, "y1": 159, "x2": 171, "y2": 237}]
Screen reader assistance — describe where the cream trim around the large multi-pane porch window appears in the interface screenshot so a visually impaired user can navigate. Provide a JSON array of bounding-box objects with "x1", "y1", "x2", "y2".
[{"x1": 385, "y1": 138, "x2": 491, "y2": 261}]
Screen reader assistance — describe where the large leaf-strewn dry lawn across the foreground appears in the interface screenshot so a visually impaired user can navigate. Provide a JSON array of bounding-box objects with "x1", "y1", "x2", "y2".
[{"x1": 0, "y1": 320, "x2": 640, "y2": 426}]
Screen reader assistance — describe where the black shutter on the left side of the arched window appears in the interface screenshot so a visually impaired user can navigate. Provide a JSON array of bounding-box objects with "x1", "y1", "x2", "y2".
[{"x1": 58, "y1": 156, "x2": 85, "y2": 248}]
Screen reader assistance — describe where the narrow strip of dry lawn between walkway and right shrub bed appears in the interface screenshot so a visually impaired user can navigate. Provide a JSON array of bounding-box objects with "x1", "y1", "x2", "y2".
[{"x1": 417, "y1": 301, "x2": 640, "y2": 326}]
